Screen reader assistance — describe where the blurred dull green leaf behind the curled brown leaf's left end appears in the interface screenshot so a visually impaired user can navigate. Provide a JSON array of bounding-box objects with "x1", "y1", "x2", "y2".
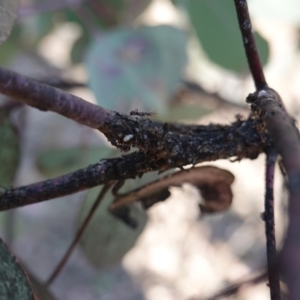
[{"x1": 79, "y1": 172, "x2": 168, "y2": 268}]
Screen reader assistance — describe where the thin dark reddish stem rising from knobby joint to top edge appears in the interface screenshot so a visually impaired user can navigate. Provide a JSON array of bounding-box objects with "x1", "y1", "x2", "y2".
[{"x1": 234, "y1": 0, "x2": 267, "y2": 90}]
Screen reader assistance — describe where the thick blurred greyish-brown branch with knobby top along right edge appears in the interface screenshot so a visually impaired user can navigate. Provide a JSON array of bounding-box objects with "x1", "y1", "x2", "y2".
[{"x1": 247, "y1": 88, "x2": 300, "y2": 300}]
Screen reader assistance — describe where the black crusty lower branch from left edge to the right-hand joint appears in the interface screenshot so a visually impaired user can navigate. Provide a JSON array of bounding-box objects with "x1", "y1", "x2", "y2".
[{"x1": 0, "y1": 119, "x2": 269, "y2": 211}]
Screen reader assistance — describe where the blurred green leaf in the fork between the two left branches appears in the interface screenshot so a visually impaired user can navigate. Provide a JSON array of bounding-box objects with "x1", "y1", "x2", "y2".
[{"x1": 37, "y1": 147, "x2": 120, "y2": 178}]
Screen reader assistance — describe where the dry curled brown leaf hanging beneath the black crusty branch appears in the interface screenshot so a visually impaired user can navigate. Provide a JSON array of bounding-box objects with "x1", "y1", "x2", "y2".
[{"x1": 110, "y1": 166, "x2": 234, "y2": 213}]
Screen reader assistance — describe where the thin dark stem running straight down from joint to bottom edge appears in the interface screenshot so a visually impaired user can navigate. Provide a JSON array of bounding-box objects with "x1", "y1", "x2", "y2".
[{"x1": 264, "y1": 149, "x2": 281, "y2": 300}]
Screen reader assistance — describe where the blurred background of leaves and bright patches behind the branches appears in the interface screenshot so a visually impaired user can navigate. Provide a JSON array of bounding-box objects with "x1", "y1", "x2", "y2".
[{"x1": 0, "y1": 0, "x2": 300, "y2": 300}]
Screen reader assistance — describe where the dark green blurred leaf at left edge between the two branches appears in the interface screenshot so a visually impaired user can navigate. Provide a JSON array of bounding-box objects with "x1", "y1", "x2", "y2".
[{"x1": 0, "y1": 109, "x2": 20, "y2": 188}]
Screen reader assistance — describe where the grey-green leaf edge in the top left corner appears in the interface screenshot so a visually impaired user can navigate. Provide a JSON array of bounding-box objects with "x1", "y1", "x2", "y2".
[{"x1": 0, "y1": 0, "x2": 20, "y2": 44}]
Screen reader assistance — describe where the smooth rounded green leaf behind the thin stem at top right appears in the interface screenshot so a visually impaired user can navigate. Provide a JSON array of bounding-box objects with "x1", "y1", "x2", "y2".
[{"x1": 187, "y1": 0, "x2": 269, "y2": 72}]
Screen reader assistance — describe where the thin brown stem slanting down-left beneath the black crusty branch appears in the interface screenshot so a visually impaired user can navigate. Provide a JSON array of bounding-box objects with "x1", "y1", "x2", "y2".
[{"x1": 46, "y1": 184, "x2": 111, "y2": 286}]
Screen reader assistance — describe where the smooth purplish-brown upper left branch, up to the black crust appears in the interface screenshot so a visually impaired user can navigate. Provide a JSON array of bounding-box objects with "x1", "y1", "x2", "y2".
[{"x1": 0, "y1": 67, "x2": 110, "y2": 130}]
